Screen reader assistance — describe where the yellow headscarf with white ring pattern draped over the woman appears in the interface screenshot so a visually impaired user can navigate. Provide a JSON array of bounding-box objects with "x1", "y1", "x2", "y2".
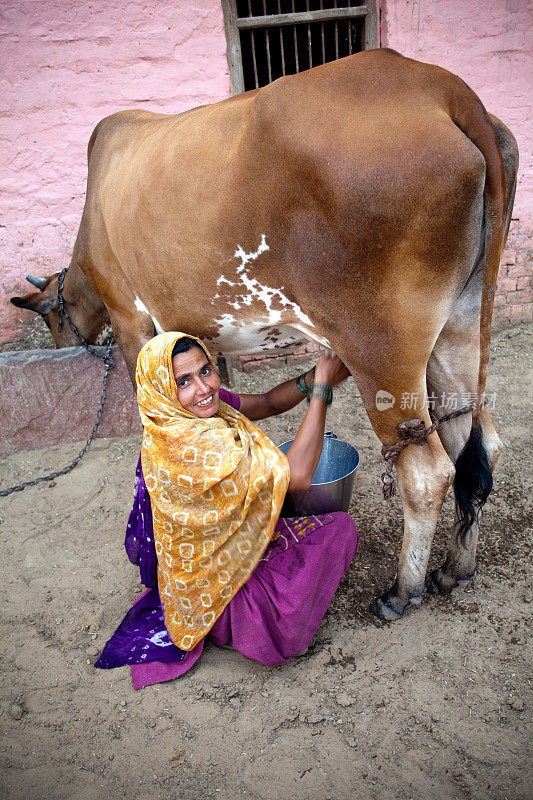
[{"x1": 136, "y1": 333, "x2": 289, "y2": 650}]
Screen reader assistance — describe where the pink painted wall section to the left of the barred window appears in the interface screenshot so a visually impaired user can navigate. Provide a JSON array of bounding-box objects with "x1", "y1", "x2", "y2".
[{"x1": 0, "y1": 0, "x2": 231, "y2": 343}]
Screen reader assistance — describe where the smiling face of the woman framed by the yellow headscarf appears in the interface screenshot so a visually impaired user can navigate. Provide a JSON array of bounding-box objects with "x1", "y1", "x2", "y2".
[{"x1": 172, "y1": 347, "x2": 220, "y2": 419}]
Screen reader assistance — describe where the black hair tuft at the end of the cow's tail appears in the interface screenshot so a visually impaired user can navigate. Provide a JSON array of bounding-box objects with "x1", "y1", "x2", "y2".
[{"x1": 453, "y1": 424, "x2": 492, "y2": 536}]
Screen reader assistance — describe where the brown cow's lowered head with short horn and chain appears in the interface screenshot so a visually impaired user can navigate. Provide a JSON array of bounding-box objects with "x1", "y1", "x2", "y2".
[{"x1": 11, "y1": 267, "x2": 111, "y2": 348}]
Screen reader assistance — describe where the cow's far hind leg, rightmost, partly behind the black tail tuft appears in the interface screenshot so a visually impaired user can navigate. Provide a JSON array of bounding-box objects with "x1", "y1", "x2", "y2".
[{"x1": 427, "y1": 275, "x2": 501, "y2": 594}]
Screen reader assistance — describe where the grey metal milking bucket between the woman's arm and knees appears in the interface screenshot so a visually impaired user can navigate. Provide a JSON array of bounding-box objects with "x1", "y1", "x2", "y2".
[{"x1": 279, "y1": 431, "x2": 359, "y2": 517}]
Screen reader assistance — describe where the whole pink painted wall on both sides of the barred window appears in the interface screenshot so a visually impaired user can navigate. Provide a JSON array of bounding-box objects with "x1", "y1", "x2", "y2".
[{"x1": 0, "y1": 0, "x2": 533, "y2": 349}]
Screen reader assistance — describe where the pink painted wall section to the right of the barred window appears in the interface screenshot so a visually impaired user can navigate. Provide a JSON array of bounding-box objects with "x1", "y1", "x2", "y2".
[{"x1": 381, "y1": 0, "x2": 533, "y2": 323}]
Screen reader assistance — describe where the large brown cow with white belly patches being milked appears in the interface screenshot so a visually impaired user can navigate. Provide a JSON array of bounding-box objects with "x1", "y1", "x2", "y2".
[{"x1": 11, "y1": 50, "x2": 517, "y2": 619}]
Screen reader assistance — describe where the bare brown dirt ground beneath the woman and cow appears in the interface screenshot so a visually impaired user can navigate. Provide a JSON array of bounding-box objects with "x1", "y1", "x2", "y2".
[{"x1": 0, "y1": 327, "x2": 533, "y2": 800}]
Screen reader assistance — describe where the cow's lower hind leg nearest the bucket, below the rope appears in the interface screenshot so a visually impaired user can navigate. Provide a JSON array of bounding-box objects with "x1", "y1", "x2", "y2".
[{"x1": 372, "y1": 433, "x2": 454, "y2": 621}]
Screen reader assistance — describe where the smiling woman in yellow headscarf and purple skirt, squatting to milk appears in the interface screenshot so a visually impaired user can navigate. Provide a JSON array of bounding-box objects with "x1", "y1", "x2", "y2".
[{"x1": 95, "y1": 333, "x2": 357, "y2": 688}]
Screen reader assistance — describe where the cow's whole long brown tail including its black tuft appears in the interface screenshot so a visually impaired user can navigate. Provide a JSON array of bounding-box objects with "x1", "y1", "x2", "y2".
[{"x1": 451, "y1": 84, "x2": 506, "y2": 536}]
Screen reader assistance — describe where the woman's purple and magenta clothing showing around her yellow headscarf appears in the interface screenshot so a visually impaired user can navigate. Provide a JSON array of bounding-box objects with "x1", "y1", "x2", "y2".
[{"x1": 95, "y1": 390, "x2": 358, "y2": 689}]
